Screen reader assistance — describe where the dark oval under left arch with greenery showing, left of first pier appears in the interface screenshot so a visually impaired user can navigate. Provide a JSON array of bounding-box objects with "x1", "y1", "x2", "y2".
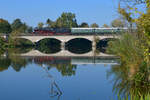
[{"x1": 35, "y1": 38, "x2": 61, "y2": 54}]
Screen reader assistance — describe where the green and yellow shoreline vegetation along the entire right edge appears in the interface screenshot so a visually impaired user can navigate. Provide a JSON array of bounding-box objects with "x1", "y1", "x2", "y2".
[{"x1": 107, "y1": 0, "x2": 150, "y2": 100}]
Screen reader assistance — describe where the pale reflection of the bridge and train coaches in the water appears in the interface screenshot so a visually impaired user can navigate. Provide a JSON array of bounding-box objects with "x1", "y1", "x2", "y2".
[{"x1": 15, "y1": 50, "x2": 119, "y2": 65}]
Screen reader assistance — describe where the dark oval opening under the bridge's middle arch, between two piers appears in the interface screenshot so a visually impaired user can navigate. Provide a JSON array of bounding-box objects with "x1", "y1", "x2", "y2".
[{"x1": 65, "y1": 38, "x2": 92, "y2": 54}]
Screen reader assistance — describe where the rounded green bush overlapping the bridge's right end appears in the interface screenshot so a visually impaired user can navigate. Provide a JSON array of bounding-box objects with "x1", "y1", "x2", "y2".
[{"x1": 107, "y1": 33, "x2": 148, "y2": 66}]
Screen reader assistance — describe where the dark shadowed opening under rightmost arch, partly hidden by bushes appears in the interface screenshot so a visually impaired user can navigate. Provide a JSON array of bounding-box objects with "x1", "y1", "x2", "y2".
[{"x1": 96, "y1": 38, "x2": 118, "y2": 54}]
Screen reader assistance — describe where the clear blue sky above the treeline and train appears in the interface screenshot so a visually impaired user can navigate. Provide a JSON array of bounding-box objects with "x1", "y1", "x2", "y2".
[{"x1": 0, "y1": 0, "x2": 119, "y2": 27}]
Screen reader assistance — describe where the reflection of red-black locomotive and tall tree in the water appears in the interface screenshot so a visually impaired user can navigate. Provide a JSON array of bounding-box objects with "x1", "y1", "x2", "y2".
[{"x1": 33, "y1": 57, "x2": 76, "y2": 76}]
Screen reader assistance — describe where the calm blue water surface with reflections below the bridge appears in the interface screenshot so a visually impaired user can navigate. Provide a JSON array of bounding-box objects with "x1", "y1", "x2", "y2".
[{"x1": 0, "y1": 56, "x2": 117, "y2": 100}]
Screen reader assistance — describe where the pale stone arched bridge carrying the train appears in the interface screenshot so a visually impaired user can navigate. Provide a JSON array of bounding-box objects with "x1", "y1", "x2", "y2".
[{"x1": 13, "y1": 35, "x2": 119, "y2": 51}]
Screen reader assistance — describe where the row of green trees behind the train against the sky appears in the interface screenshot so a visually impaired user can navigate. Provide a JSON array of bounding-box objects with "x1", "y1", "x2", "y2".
[{"x1": 0, "y1": 12, "x2": 126, "y2": 34}]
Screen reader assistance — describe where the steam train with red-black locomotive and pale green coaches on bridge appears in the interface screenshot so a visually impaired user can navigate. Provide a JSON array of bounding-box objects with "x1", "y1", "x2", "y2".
[{"x1": 32, "y1": 27, "x2": 128, "y2": 35}]
